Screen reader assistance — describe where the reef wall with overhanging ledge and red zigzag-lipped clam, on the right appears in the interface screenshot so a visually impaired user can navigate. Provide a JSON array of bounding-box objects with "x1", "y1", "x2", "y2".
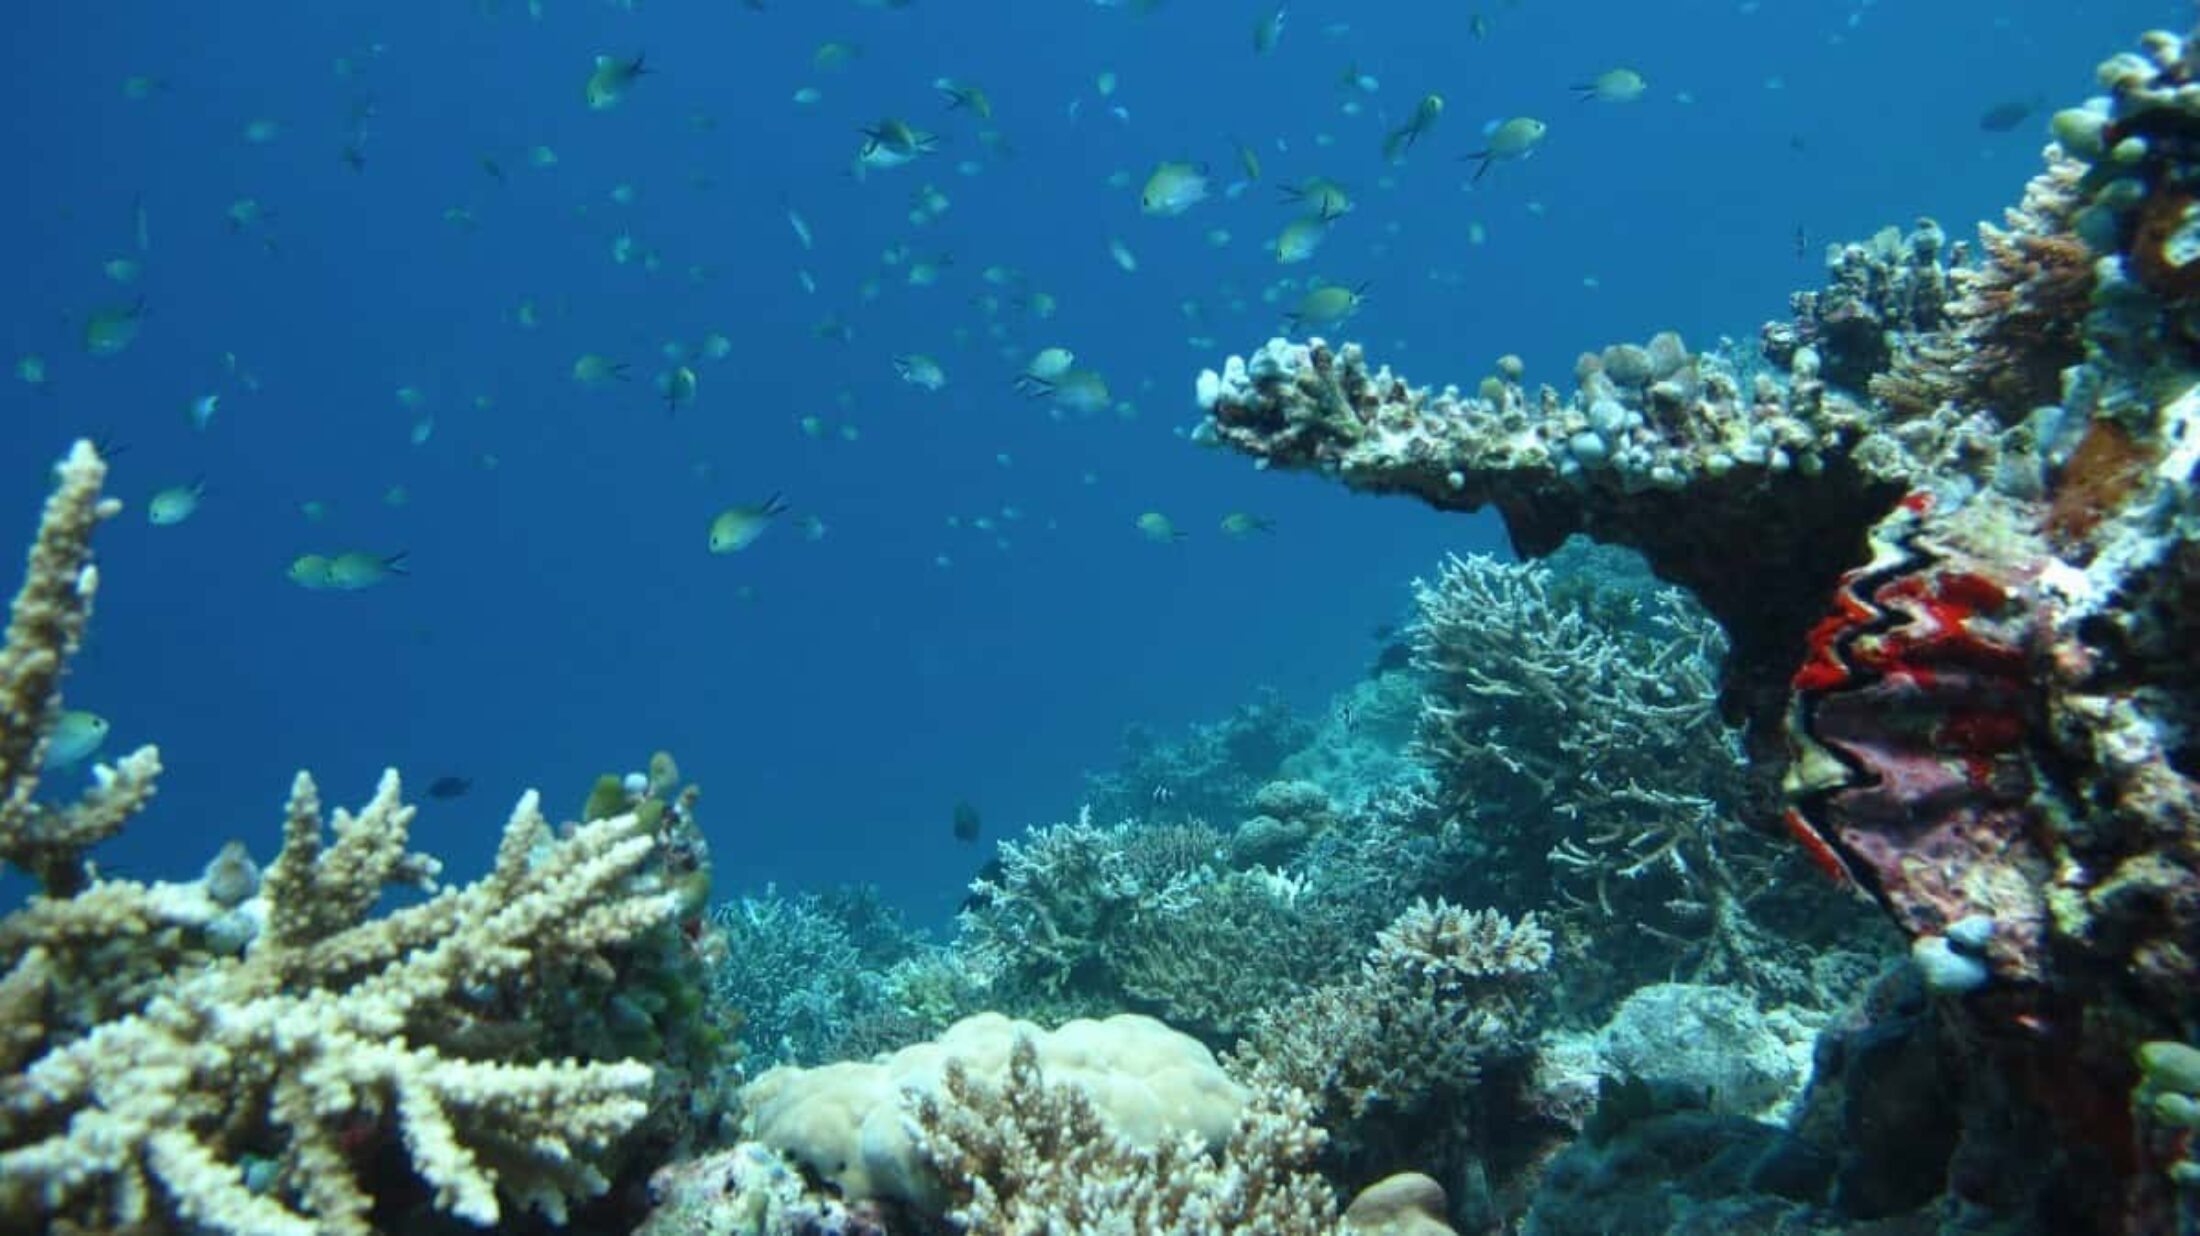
[{"x1": 1199, "y1": 19, "x2": 2200, "y2": 1232}]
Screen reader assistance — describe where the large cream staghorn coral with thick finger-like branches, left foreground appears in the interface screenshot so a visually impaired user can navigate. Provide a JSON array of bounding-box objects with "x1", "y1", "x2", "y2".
[{"x1": 0, "y1": 442, "x2": 675, "y2": 1236}]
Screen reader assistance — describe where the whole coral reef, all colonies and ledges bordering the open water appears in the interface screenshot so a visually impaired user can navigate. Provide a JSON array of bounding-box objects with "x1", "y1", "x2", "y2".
[{"x1": 0, "y1": 16, "x2": 2200, "y2": 1236}]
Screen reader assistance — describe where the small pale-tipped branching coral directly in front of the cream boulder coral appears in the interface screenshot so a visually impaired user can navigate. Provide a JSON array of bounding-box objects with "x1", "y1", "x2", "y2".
[{"x1": 909, "y1": 1036, "x2": 1342, "y2": 1236}]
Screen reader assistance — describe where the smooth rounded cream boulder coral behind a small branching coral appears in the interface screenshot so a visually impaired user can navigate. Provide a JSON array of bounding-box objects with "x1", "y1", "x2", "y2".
[{"x1": 741, "y1": 1014, "x2": 1250, "y2": 1212}]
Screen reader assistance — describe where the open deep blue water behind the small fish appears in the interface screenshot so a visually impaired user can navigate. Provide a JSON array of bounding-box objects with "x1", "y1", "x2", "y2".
[{"x1": 0, "y1": 0, "x2": 2187, "y2": 917}]
